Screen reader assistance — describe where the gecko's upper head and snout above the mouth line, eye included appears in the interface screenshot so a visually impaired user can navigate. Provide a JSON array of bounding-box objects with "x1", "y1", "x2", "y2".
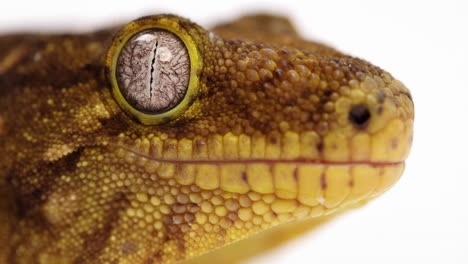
[{"x1": 106, "y1": 15, "x2": 414, "y2": 165}]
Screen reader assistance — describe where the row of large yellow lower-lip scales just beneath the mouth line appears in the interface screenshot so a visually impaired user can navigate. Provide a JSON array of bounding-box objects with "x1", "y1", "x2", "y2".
[{"x1": 134, "y1": 159, "x2": 404, "y2": 216}]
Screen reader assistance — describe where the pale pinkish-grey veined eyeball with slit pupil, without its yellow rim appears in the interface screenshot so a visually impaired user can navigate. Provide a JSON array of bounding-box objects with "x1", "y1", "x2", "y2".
[{"x1": 117, "y1": 30, "x2": 190, "y2": 114}]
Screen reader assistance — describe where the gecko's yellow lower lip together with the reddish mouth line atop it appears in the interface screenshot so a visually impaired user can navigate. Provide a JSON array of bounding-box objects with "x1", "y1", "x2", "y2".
[{"x1": 117, "y1": 145, "x2": 405, "y2": 203}]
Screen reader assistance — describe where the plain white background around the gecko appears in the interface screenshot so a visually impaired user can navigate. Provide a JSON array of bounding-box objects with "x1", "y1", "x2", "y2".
[{"x1": 0, "y1": 0, "x2": 468, "y2": 264}]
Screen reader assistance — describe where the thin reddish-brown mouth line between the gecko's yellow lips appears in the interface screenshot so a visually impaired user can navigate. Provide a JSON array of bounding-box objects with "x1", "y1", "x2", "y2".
[{"x1": 116, "y1": 145, "x2": 404, "y2": 167}]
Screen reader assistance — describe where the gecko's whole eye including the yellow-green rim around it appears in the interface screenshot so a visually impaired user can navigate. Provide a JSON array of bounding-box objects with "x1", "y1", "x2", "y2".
[{"x1": 106, "y1": 15, "x2": 202, "y2": 125}]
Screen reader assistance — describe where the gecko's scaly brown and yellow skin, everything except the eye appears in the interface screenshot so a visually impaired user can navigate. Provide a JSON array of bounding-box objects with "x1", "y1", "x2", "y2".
[{"x1": 0, "y1": 15, "x2": 414, "y2": 263}]
